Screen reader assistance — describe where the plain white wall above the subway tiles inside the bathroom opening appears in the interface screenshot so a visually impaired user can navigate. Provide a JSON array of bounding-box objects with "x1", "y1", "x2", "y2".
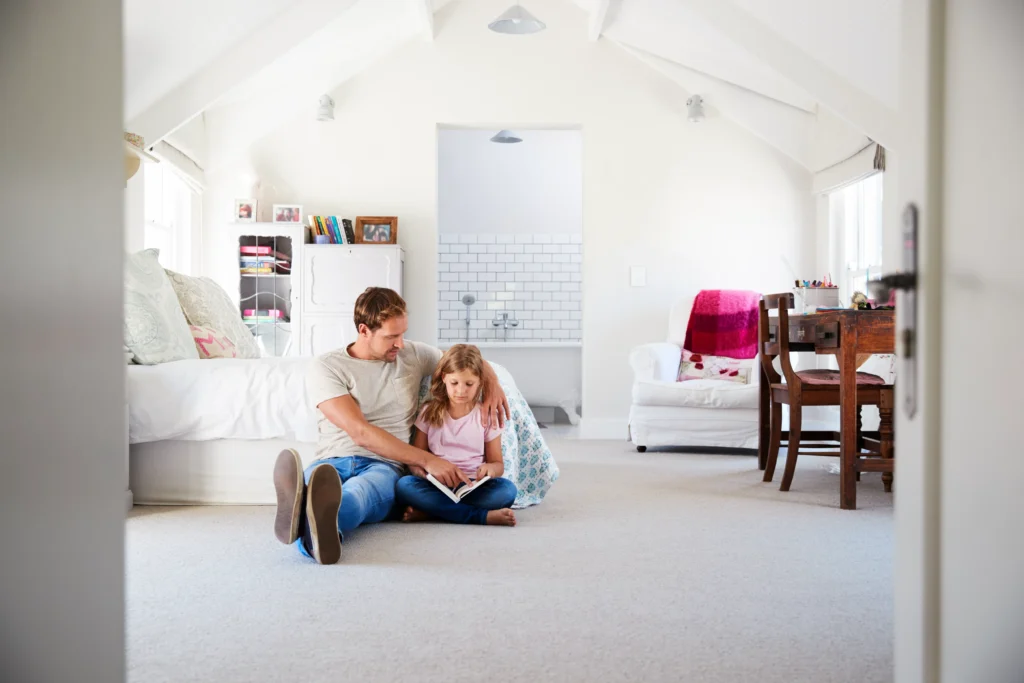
[{"x1": 437, "y1": 128, "x2": 583, "y2": 234}]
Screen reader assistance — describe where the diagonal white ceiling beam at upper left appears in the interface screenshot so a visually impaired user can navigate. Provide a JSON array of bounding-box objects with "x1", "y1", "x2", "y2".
[{"x1": 127, "y1": 0, "x2": 355, "y2": 145}]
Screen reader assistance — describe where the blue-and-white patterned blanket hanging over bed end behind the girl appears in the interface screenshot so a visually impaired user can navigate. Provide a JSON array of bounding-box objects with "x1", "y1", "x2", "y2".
[{"x1": 420, "y1": 362, "x2": 559, "y2": 509}]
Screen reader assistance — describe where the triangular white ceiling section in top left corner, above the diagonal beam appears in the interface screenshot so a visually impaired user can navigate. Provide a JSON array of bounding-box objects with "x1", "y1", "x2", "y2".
[{"x1": 124, "y1": 0, "x2": 301, "y2": 120}]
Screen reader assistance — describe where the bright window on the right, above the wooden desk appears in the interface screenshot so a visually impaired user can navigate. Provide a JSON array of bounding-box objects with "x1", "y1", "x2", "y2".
[{"x1": 828, "y1": 173, "x2": 882, "y2": 300}]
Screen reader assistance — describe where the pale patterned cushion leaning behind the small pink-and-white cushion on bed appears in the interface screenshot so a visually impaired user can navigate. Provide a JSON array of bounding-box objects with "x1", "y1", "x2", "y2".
[{"x1": 167, "y1": 270, "x2": 260, "y2": 358}]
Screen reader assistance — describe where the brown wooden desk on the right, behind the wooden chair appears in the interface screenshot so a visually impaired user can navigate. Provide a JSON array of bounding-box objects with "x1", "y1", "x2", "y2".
[{"x1": 758, "y1": 309, "x2": 896, "y2": 510}]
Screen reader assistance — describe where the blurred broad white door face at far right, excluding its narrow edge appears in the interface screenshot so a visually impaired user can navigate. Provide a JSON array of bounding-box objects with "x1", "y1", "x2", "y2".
[{"x1": 939, "y1": 0, "x2": 1024, "y2": 683}]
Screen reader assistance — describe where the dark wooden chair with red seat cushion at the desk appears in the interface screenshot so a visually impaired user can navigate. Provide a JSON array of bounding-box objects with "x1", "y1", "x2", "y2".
[{"x1": 759, "y1": 293, "x2": 893, "y2": 490}]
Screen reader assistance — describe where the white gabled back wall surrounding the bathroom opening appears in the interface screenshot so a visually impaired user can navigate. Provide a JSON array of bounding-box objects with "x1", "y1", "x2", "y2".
[{"x1": 204, "y1": 0, "x2": 815, "y2": 438}]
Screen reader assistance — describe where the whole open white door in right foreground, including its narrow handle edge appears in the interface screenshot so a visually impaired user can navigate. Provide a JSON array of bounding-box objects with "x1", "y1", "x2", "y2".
[{"x1": 895, "y1": 0, "x2": 1024, "y2": 683}]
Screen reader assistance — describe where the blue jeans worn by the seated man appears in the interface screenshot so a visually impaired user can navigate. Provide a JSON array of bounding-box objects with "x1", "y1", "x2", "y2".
[{"x1": 295, "y1": 456, "x2": 401, "y2": 557}]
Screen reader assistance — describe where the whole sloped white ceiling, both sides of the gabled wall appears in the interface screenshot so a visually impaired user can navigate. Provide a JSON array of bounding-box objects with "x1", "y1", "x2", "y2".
[{"x1": 125, "y1": 0, "x2": 901, "y2": 170}]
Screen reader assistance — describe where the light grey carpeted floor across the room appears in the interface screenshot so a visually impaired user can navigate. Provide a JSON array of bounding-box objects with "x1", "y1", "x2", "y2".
[{"x1": 127, "y1": 440, "x2": 893, "y2": 683}]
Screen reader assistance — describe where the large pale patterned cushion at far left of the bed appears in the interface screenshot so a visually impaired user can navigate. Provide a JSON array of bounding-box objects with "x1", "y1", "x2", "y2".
[{"x1": 124, "y1": 249, "x2": 199, "y2": 366}]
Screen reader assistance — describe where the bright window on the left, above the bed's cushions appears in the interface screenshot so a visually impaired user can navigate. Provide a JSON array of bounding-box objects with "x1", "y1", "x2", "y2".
[{"x1": 142, "y1": 163, "x2": 199, "y2": 274}]
